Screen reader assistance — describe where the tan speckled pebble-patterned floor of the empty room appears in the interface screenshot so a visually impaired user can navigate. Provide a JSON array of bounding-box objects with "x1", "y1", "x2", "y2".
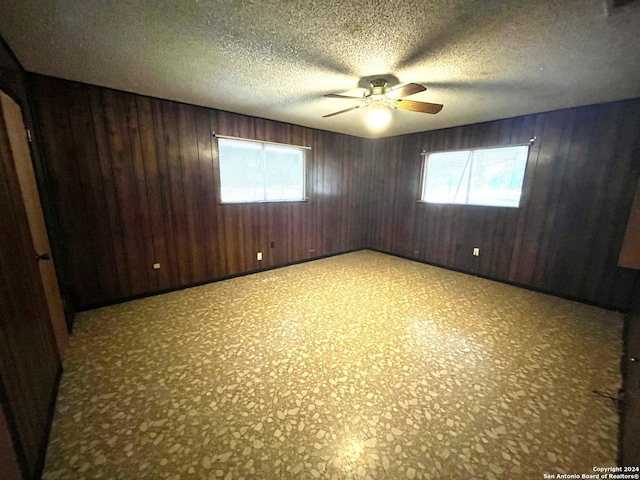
[{"x1": 43, "y1": 251, "x2": 622, "y2": 480}]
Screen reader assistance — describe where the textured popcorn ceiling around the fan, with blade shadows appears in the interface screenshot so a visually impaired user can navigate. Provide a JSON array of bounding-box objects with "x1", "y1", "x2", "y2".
[{"x1": 0, "y1": 0, "x2": 640, "y2": 137}]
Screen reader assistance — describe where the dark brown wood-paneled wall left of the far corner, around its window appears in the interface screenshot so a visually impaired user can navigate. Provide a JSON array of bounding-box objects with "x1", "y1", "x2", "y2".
[{"x1": 33, "y1": 75, "x2": 366, "y2": 308}]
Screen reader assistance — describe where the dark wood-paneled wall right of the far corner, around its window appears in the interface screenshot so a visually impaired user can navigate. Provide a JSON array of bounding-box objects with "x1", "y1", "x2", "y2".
[{"x1": 367, "y1": 100, "x2": 640, "y2": 309}]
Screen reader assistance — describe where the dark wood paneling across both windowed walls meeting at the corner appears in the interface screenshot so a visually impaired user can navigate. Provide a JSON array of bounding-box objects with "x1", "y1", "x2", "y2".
[{"x1": 33, "y1": 72, "x2": 640, "y2": 309}]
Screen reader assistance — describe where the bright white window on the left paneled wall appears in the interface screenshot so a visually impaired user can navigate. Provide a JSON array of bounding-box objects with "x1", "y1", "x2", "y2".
[{"x1": 218, "y1": 137, "x2": 307, "y2": 203}]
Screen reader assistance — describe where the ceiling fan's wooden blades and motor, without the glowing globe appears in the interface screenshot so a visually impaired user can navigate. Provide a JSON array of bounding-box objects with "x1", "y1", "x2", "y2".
[{"x1": 322, "y1": 78, "x2": 443, "y2": 118}]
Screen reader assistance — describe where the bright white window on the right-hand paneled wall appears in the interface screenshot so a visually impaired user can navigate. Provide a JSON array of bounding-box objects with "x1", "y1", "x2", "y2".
[{"x1": 422, "y1": 145, "x2": 529, "y2": 207}]
